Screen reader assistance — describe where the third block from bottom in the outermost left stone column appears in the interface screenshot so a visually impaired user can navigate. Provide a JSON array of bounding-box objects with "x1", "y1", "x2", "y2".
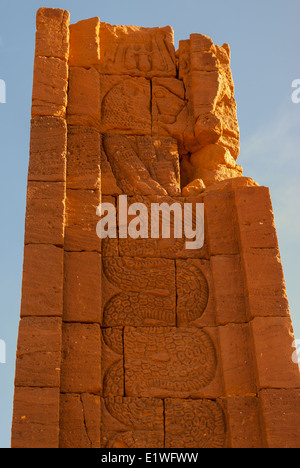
[{"x1": 21, "y1": 244, "x2": 64, "y2": 317}]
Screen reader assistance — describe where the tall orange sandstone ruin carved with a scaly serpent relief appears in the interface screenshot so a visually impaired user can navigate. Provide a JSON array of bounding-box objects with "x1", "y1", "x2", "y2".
[{"x1": 12, "y1": 8, "x2": 300, "y2": 448}]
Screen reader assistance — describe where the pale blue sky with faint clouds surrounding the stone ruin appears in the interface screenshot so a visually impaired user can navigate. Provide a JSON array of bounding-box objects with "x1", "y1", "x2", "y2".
[{"x1": 0, "y1": 0, "x2": 300, "y2": 448}]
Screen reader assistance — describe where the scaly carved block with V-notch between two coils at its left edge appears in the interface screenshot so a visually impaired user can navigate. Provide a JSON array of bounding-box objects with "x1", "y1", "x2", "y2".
[{"x1": 103, "y1": 257, "x2": 176, "y2": 327}]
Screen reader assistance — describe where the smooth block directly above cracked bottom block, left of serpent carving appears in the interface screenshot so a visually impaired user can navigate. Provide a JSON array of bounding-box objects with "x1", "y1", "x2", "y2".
[{"x1": 60, "y1": 323, "x2": 102, "y2": 394}]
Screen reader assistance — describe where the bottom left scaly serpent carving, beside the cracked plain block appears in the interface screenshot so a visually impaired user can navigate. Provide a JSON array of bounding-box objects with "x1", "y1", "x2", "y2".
[{"x1": 101, "y1": 397, "x2": 164, "y2": 448}]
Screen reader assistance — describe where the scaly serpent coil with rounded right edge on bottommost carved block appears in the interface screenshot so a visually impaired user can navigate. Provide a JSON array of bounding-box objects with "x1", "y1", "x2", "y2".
[{"x1": 165, "y1": 399, "x2": 226, "y2": 448}]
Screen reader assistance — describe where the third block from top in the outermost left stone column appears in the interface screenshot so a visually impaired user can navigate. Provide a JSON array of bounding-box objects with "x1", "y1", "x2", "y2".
[{"x1": 28, "y1": 117, "x2": 67, "y2": 182}]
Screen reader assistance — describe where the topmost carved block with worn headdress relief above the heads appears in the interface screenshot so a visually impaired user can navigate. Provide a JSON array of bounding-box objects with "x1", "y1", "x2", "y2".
[{"x1": 99, "y1": 22, "x2": 176, "y2": 78}]
